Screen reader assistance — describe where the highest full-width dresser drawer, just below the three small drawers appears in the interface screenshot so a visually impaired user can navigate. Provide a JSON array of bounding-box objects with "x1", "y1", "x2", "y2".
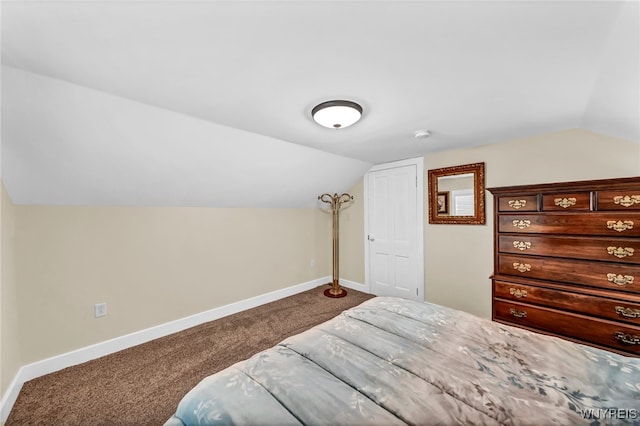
[{"x1": 498, "y1": 212, "x2": 640, "y2": 237}]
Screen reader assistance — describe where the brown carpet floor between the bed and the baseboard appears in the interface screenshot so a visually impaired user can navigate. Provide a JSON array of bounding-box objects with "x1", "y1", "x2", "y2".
[{"x1": 6, "y1": 286, "x2": 373, "y2": 426}]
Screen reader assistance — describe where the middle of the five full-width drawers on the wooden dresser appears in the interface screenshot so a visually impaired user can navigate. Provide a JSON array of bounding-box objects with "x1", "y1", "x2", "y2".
[{"x1": 496, "y1": 254, "x2": 640, "y2": 293}]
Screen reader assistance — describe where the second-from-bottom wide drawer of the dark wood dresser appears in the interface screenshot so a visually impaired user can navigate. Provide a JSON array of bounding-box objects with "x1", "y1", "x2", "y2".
[{"x1": 493, "y1": 281, "x2": 640, "y2": 325}]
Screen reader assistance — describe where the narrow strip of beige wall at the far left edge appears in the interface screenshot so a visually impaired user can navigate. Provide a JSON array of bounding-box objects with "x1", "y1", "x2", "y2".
[{"x1": 0, "y1": 182, "x2": 21, "y2": 395}]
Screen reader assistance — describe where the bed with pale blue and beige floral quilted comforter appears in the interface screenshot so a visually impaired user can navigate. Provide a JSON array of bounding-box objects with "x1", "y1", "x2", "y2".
[{"x1": 165, "y1": 297, "x2": 640, "y2": 426}]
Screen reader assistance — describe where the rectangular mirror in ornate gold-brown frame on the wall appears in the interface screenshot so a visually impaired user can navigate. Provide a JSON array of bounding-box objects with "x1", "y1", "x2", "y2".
[{"x1": 427, "y1": 163, "x2": 485, "y2": 225}]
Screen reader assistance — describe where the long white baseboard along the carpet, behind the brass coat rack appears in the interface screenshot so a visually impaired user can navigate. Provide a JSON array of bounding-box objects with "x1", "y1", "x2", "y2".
[{"x1": 0, "y1": 276, "x2": 330, "y2": 424}]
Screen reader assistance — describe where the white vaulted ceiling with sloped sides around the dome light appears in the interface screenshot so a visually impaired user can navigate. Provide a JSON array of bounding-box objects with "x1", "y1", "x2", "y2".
[{"x1": 1, "y1": 0, "x2": 640, "y2": 207}]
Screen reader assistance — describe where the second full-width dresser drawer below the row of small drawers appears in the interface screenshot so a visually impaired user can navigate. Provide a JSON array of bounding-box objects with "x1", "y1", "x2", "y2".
[{"x1": 498, "y1": 235, "x2": 640, "y2": 263}]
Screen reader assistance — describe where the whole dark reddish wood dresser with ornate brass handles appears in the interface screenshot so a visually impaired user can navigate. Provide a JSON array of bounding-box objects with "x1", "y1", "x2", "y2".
[{"x1": 489, "y1": 178, "x2": 640, "y2": 356}]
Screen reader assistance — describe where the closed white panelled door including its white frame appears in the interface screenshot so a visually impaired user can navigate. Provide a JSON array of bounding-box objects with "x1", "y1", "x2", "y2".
[{"x1": 365, "y1": 159, "x2": 424, "y2": 300}]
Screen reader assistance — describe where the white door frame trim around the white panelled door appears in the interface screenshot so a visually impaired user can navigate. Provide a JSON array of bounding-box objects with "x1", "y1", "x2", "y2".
[{"x1": 364, "y1": 157, "x2": 425, "y2": 301}]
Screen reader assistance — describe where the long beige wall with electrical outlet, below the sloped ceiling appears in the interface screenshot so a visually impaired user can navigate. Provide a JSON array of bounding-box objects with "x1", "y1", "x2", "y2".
[{"x1": 15, "y1": 205, "x2": 331, "y2": 364}]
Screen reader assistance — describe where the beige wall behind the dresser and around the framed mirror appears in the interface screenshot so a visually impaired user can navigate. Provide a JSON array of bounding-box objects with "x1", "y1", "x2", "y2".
[{"x1": 424, "y1": 130, "x2": 640, "y2": 317}]
